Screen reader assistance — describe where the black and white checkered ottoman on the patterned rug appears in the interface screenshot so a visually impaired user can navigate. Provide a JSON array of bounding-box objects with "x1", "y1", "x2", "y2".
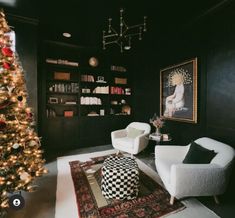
[{"x1": 101, "y1": 156, "x2": 139, "y2": 199}]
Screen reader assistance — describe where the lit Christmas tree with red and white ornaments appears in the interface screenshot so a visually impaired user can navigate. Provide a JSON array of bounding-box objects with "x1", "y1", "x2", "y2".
[{"x1": 0, "y1": 11, "x2": 47, "y2": 212}]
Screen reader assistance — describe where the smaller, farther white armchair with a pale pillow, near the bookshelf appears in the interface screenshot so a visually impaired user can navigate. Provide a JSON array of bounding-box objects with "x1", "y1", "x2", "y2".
[{"x1": 111, "y1": 122, "x2": 151, "y2": 156}]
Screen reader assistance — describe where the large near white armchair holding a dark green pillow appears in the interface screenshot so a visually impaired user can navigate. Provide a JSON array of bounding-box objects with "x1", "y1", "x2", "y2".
[{"x1": 155, "y1": 137, "x2": 235, "y2": 204}]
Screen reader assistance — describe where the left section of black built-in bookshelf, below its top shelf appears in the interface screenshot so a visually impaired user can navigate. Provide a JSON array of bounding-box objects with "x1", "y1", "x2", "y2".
[{"x1": 46, "y1": 64, "x2": 79, "y2": 118}]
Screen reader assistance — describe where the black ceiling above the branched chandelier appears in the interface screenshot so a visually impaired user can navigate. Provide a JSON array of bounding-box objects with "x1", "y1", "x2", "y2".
[{"x1": 0, "y1": 0, "x2": 235, "y2": 49}]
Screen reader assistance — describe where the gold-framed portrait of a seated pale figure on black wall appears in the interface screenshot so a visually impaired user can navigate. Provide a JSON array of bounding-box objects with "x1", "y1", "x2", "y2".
[{"x1": 160, "y1": 58, "x2": 197, "y2": 123}]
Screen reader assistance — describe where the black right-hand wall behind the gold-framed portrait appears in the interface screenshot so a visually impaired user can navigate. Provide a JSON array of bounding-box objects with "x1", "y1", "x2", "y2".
[{"x1": 130, "y1": 3, "x2": 235, "y2": 148}]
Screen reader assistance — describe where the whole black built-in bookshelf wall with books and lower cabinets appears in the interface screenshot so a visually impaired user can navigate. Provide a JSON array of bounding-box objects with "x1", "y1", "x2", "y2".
[{"x1": 39, "y1": 42, "x2": 132, "y2": 147}]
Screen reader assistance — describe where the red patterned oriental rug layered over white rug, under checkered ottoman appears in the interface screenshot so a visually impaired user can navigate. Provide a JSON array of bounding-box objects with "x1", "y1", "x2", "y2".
[{"x1": 69, "y1": 156, "x2": 185, "y2": 218}]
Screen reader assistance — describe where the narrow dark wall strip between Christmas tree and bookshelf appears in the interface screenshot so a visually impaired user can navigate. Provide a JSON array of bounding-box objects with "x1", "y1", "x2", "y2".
[{"x1": 6, "y1": 14, "x2": 38, "y2": 127}]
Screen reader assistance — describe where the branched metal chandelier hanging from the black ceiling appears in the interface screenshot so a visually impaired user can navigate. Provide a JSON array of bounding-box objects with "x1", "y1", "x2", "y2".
[{"x1": 103, "y1": 8, "x2": 147, "y2": 52}]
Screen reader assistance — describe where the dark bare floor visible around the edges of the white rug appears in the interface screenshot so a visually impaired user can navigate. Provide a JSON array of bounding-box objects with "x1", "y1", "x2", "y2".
[{"x1": 6, "y1": 145, "x2": 235, "y2": 218}]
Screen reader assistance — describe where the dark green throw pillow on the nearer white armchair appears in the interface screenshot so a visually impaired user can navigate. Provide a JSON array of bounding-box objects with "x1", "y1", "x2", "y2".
[{"x1": 183, "y1": 142, "x2": 217, "y2": 164}]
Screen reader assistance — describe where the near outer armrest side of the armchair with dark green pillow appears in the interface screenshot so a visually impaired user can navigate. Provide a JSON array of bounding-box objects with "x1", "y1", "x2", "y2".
[{"x1": 170, "y1": 164, "x2": 226, "y2": 197}]
